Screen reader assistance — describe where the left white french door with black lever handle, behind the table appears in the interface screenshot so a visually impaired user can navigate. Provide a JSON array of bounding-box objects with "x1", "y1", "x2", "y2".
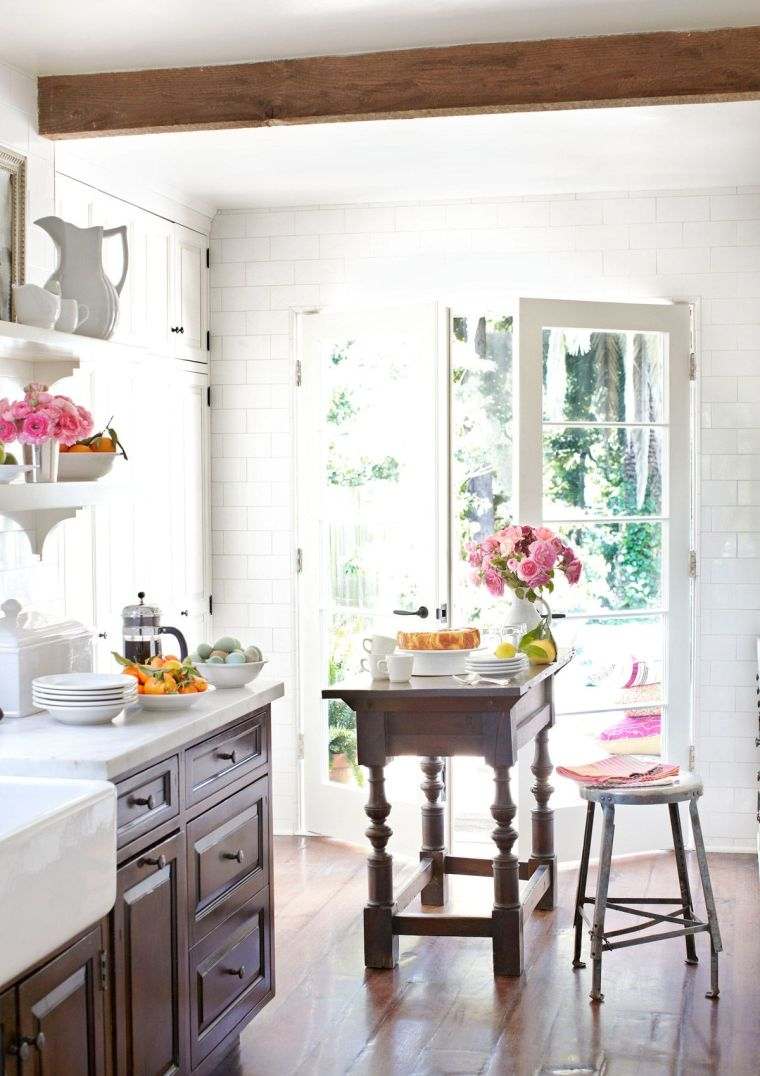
[{"x1": 297, "y1": 305, "x2": 448, "y2": 852}]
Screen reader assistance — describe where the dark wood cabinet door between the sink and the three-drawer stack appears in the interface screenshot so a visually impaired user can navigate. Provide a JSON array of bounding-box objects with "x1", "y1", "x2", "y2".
[{"x1": 113, "y1": 833, "x2": 189, "y2": 1076}]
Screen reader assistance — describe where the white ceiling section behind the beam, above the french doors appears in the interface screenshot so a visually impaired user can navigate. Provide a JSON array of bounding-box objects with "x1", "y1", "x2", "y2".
[{"x1": 56, "y1": 101, "x2": 760, "y2": 209}]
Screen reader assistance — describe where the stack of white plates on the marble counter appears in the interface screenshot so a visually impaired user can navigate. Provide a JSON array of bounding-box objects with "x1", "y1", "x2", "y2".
[{"x1": 31, "y1": 673, "x2": 139, "y2": 725}]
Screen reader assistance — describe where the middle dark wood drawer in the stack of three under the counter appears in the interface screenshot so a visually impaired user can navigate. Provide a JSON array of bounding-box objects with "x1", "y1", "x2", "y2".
[{"x1": 187, "y1": 777, "x2": 269, "y2": 942}]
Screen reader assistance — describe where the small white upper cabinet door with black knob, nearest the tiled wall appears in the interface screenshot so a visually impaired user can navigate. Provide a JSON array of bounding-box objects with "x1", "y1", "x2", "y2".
[{"x1": 170, "y1": 225, "x2": 209, "y2": 363}]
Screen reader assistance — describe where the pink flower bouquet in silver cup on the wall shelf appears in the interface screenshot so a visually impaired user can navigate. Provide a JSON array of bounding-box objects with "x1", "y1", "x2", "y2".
[{"x1": 0, "y1": 382, "x2": 93, "y2": 445}]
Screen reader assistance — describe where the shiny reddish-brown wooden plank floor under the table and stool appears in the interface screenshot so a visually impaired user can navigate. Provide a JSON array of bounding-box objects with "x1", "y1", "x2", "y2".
[{"x1": 219, "y1": 838, "x2": 760, "y2": 1076}]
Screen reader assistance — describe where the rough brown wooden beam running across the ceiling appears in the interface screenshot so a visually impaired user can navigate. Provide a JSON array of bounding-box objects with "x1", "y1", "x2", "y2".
[{"x1": 39, "y1": 26, "x2": 760, "y2": 138}]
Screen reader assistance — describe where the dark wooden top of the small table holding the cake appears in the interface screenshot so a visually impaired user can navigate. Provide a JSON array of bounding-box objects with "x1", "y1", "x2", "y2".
[{"x1": 322, "y1": 650, "x2": 573, "y2": 700}]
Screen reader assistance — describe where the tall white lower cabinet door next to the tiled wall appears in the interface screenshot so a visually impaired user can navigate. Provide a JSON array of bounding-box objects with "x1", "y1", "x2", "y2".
[{"x1": 167, "y1": 371, "x2": 211, "y2": 651}]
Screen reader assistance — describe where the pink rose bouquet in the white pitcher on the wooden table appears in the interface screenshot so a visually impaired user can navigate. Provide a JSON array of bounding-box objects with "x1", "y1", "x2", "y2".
[{"x1": 467, "y1": 526, "x2": 582, "y2": 601}]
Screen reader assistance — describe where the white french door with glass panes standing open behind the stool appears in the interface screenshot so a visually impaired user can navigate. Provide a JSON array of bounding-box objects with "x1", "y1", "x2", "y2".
[{"x1": 515, "y1": 299, "x2": 691, "y2": 861}]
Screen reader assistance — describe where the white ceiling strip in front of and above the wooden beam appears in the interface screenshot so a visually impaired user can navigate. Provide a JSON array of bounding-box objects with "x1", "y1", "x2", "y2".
[{"x1": 0, "y1": 0, "x2": 760, "y2": 74}]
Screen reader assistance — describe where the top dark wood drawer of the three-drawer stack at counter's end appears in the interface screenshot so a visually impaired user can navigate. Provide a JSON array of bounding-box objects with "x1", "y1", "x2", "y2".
[{"x1": 186, "y1": 709, "x2": 269, "y2": 804}]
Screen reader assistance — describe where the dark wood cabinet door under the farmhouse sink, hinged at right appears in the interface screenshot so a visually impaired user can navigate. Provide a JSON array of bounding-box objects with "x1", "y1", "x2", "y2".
[{"x1": 18, "y1": 928, "x2": 105, "y2": 1076}]
